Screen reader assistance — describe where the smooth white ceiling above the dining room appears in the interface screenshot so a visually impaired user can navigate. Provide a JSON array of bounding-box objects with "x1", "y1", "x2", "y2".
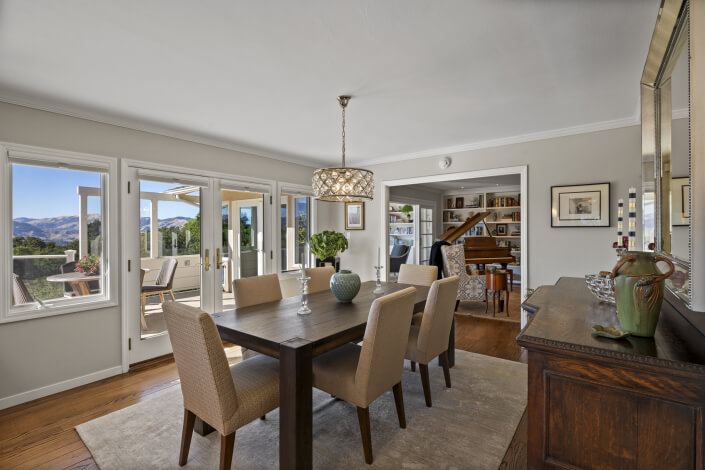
[{"x1": 0, "y1": 0, "x2": 660, "y2": 165}]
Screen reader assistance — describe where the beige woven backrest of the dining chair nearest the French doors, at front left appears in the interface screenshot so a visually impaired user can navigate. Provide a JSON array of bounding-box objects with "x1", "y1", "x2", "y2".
[{"x1": 162, "y1": 302, "x2": 238, "y2": 434}]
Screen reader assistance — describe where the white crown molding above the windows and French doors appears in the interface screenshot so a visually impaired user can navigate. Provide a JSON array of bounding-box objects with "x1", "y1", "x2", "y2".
[{"x1": 0, "y1": 94, "x2": 323, "y2": 168}]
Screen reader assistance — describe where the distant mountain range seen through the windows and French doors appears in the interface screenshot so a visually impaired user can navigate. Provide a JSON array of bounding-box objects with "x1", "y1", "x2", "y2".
[{"x1": 12, "y1": 214, "x2": 192, "y2": 245}]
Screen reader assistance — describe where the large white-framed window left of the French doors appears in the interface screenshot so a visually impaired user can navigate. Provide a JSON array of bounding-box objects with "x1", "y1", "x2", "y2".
[{"x1": 0, "y1": 141, "x2": 115, "y2": 321}]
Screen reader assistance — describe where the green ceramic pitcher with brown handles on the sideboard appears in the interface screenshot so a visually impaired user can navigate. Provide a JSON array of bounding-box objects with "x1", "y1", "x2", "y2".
[{"x1": 612, "y1": 251, "x2": 675, "y2": 338}]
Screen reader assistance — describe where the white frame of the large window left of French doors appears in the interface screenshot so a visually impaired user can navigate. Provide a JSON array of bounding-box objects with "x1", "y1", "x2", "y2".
[{"x1": 0, "y1": 142, "x2": 119, "y2": 323}]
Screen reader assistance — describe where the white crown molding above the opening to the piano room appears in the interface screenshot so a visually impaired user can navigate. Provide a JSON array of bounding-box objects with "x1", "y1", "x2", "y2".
[{"x1": 356, "y1": 114, "x2": 641, "y2": 165}]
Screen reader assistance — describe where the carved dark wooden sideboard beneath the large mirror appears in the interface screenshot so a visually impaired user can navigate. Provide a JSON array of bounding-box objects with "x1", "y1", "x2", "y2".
[{"x1": 517, "y1": 278, "x2": 705, "y2": 470}]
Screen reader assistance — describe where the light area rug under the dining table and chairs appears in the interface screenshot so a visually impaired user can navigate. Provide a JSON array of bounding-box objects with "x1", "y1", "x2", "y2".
[{"x1": 76, "y1": 350, "x2": 527, "y2": 470}]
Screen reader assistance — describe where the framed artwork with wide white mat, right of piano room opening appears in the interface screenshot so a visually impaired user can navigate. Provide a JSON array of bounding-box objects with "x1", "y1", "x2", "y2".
[{"x1": 551, "y1": 183, "x2": 610, "y2": 227}]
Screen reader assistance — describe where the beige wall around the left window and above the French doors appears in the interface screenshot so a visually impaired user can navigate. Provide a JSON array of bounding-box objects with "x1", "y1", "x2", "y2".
[{"x1": 0, "y1": 102, "x2": 312, "y2": 408}]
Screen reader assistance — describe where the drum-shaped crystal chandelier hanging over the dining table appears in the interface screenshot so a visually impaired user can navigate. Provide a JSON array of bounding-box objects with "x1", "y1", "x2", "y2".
[{"x1": 313, "y1": 96, "x2": 375, "y2": 202}]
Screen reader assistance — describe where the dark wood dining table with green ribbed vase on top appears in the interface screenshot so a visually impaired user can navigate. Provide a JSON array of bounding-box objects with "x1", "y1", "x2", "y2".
[{"x1": 204, "y1": 281, "x2": 429, "y2": 469}]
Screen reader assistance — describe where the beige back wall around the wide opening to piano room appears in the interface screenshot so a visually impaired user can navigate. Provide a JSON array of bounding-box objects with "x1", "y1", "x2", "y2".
[{"x1": 329, "y1": 126, "x2": 664, "y2": 288}]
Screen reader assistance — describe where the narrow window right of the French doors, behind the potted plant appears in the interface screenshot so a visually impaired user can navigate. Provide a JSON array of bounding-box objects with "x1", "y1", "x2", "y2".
[{"x1": 281, "y1": 193, "x2": 311, "y2": 271}]
